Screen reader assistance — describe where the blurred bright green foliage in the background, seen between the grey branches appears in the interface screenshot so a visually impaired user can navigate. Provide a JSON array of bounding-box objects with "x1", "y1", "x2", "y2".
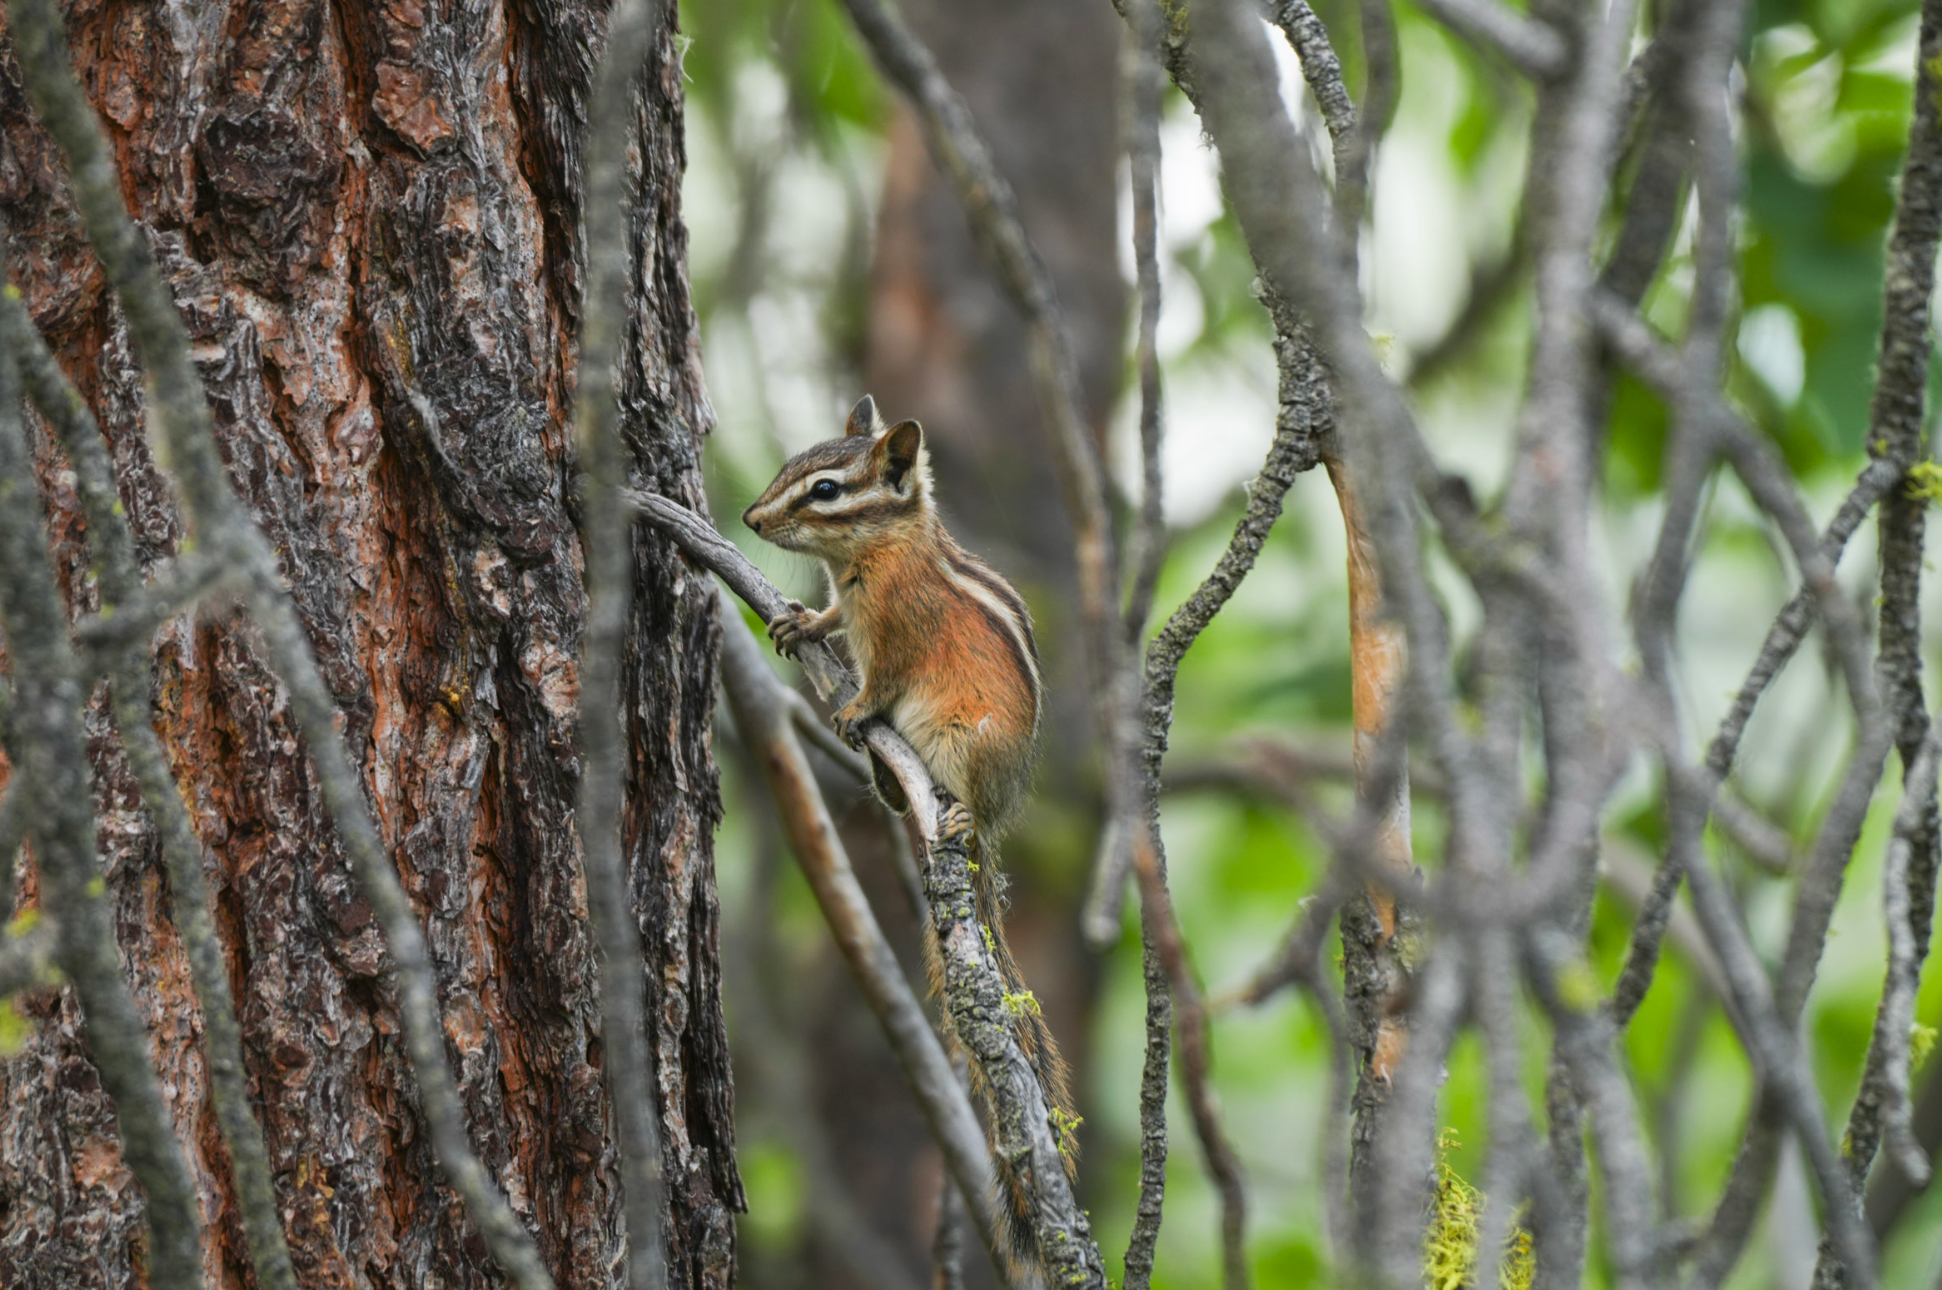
[{"x1": 684, "y1": 0, "x2": 1942, "y2": 1290}]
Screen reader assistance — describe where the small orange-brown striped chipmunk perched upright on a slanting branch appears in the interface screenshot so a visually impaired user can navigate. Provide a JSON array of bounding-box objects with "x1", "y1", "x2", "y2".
[{"x1": 742, "y1": 394, "x2": 1078, "y2": 1261}]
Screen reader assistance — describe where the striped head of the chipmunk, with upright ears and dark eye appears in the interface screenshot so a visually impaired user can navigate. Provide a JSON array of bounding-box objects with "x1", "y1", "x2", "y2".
[{"x1": 742, "y1": 394, "x2": 930, "y2": 560}]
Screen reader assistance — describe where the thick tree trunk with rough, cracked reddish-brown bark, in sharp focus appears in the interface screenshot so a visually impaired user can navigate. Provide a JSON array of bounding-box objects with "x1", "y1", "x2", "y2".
[{"x1": 0, "y1": 0, "x2": 740, "y2": 1286}]
